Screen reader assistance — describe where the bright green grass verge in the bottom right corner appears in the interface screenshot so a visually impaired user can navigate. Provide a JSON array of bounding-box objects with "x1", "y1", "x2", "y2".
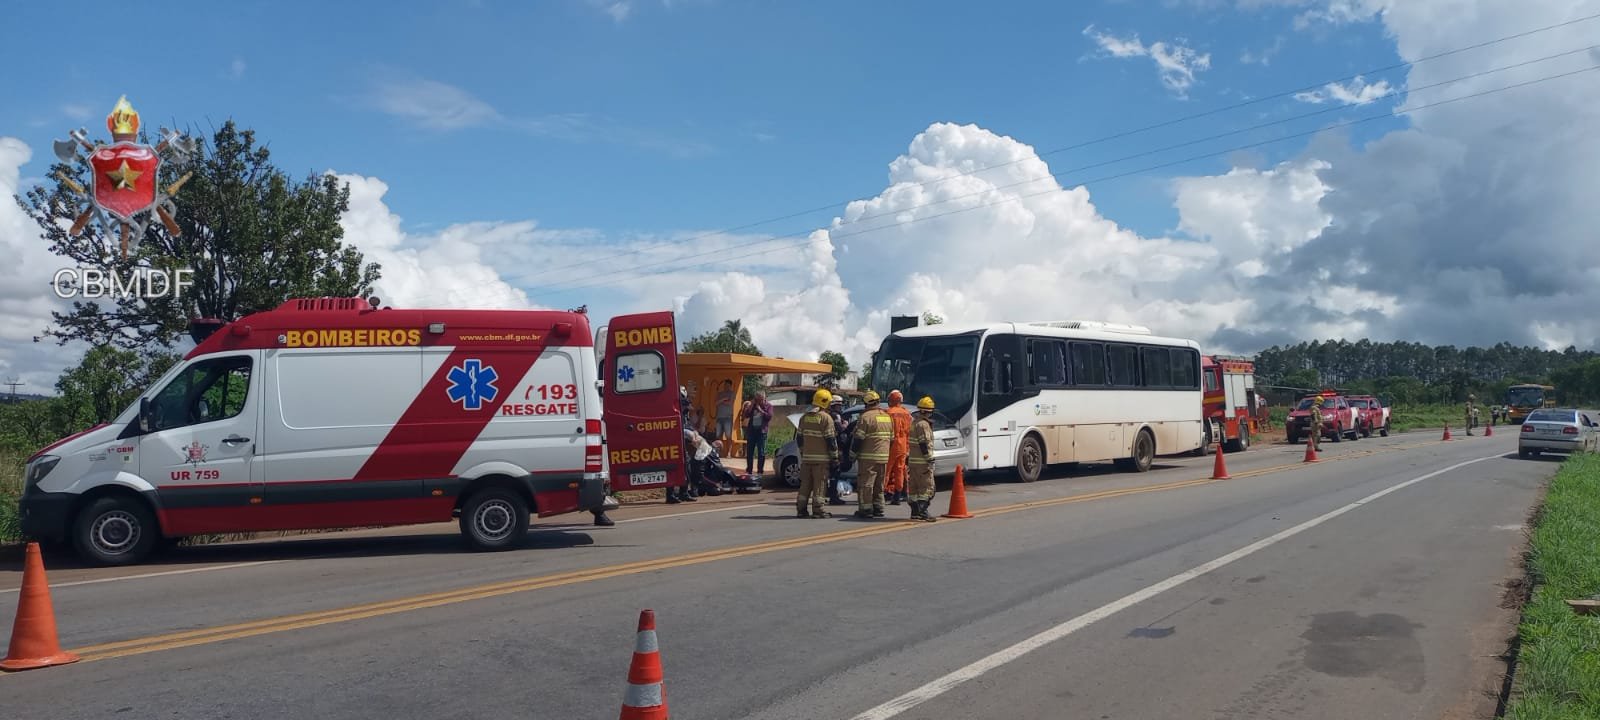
[{"x1": 1506, "y1": 454, "x2": 1600, "y2": 720}]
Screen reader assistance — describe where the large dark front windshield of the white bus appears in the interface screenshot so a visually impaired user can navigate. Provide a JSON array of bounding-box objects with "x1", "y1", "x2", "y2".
[{"x1": 872, "y1": 333, "x2": 978, "y2": 418}]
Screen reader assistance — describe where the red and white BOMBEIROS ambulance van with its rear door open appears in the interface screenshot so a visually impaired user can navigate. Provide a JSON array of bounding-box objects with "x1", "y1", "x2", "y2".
[{"x1": 21, "y1": 298, "x2": 685, "y2": 565}]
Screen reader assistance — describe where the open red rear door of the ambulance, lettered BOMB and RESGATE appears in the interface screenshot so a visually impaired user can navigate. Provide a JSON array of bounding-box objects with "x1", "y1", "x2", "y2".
[{"x1": 600, "y1": 312, "x2": 685, "y2": 490}]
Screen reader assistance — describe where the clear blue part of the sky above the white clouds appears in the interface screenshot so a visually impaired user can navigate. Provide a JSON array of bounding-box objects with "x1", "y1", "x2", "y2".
[{"x1": 0, "y1": 0, "x2": 1397, "y2": 241}]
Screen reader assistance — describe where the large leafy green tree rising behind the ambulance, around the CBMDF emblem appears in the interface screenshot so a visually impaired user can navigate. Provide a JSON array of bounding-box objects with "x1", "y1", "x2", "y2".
[{"x1": 18, "y1": 120, "x2": 379, "y2": 349}]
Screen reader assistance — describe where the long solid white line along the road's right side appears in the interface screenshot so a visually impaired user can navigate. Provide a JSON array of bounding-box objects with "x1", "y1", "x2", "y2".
[{"x1": 851, "y1": 453, "x2": 1504, "y2": 720}]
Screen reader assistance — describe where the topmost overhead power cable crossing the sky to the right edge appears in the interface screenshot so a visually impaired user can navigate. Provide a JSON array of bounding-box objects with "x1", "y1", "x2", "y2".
[{"x1": 522, "y1": 13, "x2": 1600, "y2": 278}]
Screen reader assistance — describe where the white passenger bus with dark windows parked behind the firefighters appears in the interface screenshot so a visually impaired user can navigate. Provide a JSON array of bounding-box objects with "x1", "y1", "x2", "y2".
[{"x1": 872, "y1": 320, "x2": 1205, "y2": 482}]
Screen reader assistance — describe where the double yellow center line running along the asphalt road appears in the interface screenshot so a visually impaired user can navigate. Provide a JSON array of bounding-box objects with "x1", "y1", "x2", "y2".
[{"x1": 62, "y1": 440, "x2": 1465, "y2": 662}]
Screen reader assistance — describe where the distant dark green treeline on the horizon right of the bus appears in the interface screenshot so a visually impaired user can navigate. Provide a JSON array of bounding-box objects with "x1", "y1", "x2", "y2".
[{"x1": 1256, "y1": 339, "x2": 1600, "y2": 405}]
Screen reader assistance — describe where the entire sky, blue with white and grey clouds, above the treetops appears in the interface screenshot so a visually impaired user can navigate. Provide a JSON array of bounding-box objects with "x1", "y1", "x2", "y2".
[{"x1": 9, "y1": 0, "x2": 1600, "y2": 393}]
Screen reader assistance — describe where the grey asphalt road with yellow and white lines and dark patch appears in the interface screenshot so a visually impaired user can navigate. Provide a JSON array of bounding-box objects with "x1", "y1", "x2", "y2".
[{"x1": 0, "y1": 432, "x2": 1555, "y2": 720}]
